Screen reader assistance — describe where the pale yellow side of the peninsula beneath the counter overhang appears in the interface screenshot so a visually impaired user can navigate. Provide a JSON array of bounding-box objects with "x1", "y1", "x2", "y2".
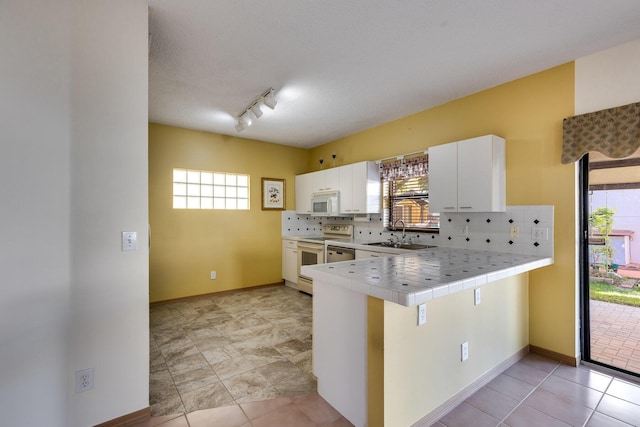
[{"x1": 382, "y1": 273, "x2": 529, "y2": 427}]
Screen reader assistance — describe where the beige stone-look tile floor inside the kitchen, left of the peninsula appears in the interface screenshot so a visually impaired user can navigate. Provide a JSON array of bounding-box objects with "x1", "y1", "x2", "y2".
[{"x1": 149, "y1": 286, "x2": 316, "y2": 416}]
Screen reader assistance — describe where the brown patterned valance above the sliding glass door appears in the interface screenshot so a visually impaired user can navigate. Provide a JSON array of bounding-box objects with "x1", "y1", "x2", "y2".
[{"x1": 561, "y1": 102, "x2": 640, "y2": 164}]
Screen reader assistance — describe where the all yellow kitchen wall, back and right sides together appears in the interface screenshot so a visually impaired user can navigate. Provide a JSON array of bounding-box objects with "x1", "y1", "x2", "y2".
[{"x1": 149, "y1": 63, "x2": 577, "y2": 357}]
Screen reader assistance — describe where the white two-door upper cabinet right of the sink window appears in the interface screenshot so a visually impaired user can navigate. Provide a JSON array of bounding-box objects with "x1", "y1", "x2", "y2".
[{"x1": 429, "y1": 135, "x2": 506, "y2": 212}]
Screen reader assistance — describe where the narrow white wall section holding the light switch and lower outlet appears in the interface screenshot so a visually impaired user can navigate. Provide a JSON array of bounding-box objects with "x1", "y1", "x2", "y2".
[{"x1": 67, "y1": 0, "x2": 149, "y2": 426}]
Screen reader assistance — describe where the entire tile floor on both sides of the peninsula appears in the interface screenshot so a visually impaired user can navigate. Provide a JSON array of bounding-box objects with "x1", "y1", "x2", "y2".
[{"x1": 145, "y1": 286, "x2": 640, "y2": 427}]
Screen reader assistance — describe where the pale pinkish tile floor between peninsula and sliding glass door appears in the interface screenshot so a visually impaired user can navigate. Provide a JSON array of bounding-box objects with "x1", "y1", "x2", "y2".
[{"x1": 435, "y1": 354, "x2": 640, "y2": 427}]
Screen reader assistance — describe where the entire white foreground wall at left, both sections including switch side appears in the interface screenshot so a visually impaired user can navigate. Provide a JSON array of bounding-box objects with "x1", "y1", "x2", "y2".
[{"x1": 0, "y1": 0, "x2": 149, "y2": 427}]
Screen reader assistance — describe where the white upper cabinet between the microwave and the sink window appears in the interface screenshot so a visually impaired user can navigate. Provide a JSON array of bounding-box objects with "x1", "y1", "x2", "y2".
[{"x1": 338, "y1": 162, "x2": 381, "y2": 215}]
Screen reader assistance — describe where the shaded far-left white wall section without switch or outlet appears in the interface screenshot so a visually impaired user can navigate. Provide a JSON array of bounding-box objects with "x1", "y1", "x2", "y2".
[{"x1": 0, "y1": 0, "x2": 71, "y2": 426}]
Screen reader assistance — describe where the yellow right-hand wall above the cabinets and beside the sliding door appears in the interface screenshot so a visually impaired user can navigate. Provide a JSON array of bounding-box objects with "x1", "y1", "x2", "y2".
[{"x1": 308, "y1": 63, "x2": 577, "y2": 357}]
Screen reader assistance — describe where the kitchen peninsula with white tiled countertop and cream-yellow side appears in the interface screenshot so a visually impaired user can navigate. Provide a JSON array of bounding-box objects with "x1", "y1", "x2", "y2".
[{"x1": 304, "y1": 247, "x2": 553, "y2": 427}]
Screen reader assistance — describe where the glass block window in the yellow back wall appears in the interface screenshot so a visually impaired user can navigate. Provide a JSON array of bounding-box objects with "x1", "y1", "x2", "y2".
[{"x1": 173, "y1": 169, "x2": 249, "y2": 210}]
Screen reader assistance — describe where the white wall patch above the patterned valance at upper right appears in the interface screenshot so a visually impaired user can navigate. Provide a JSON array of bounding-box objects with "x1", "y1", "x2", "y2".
[{"x1": 575, "y1": 39, "x2": 640, "y2": 114}]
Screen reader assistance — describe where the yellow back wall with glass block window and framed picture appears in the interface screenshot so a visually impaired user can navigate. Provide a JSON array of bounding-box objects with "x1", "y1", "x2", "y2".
[{"x1": 149, "y1": 124, "x2": 308, "y2": 302}]
